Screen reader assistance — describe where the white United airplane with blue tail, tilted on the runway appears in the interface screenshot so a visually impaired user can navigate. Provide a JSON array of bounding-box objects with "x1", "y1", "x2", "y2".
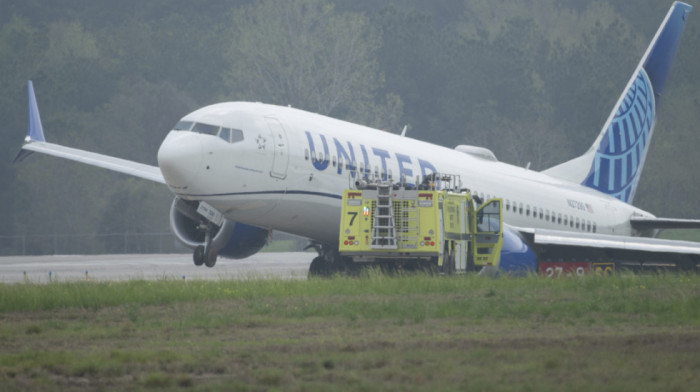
[{"x1": 15, "y1": 2, "x2": 700, "y2": 274}]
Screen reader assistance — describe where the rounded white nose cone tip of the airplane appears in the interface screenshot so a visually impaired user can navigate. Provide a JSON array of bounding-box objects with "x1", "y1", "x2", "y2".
[{"x1": 158, "y1": 131, "x2": 203, "y2": 189}]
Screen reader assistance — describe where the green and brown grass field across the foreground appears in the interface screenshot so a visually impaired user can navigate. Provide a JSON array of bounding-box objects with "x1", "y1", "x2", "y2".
[{"x1": 0, "y1": 271, "x2": 700, "y2": 391}]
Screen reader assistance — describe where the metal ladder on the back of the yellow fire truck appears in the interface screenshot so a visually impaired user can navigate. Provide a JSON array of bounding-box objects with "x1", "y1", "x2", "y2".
[{"x1": 370, "y1": 181, "x2": 398, "y2": 249}]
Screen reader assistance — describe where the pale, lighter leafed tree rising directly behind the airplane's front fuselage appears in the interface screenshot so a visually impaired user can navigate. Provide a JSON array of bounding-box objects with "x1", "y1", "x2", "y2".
[{"x1": 227, "y1": 0, "x2": 401, "y2": 127}]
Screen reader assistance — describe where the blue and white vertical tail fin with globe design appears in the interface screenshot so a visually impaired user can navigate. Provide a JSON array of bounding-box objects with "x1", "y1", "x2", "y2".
[{"x1": 544, "y1": 2, "x2": 692, "y2": 203}]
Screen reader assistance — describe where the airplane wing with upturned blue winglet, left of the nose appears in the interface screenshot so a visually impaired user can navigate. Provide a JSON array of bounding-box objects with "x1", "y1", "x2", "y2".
[{"x1": 15, "y1": 80, "x2": 165, "y2": 184}]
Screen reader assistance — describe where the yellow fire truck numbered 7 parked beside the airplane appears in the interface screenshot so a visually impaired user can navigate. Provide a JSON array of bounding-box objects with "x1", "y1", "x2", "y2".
[{"x1": 338, "y1": 174, "x2": 503, "y2": 273}]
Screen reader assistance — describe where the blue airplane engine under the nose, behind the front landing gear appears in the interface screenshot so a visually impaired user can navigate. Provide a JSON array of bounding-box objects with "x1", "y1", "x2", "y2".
[{"x1": 170, "y1": 198, "x2": 270, "y2": 266}]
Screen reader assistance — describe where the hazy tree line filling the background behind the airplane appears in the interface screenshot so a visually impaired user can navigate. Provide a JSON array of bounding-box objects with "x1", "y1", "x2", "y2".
[{"x1": 0, "y1": 0, "x2": 700, "y2": 251}]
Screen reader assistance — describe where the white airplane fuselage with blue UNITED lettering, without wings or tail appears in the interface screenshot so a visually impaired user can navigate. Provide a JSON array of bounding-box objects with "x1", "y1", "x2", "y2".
[{"x1": 158, "y1": 102, "x2": 653, "y2": 244}]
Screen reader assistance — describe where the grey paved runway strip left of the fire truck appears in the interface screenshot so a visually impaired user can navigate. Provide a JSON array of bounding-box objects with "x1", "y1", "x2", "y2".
[{"x1": 0, "y1": 252, "x2": 316, "y2": 283}]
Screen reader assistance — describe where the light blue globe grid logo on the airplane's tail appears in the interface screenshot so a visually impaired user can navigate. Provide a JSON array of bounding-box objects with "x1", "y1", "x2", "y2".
[{"x1": 583, "y1": 68, "x2": 656, "y2": 203}]
